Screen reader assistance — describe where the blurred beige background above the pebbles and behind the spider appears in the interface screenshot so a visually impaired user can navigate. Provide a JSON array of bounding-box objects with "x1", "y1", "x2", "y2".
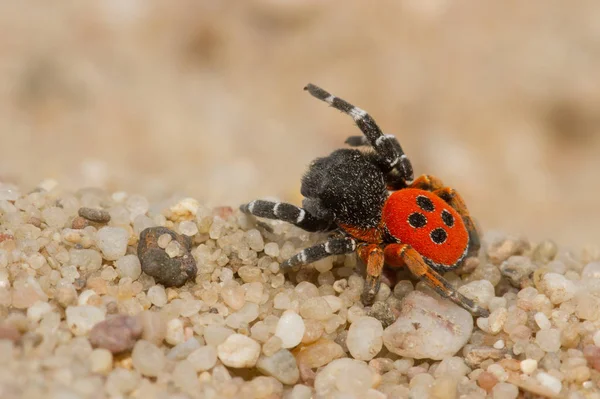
[{"x1": 0, "y1": 0, "x2": 600, "y2": 247}]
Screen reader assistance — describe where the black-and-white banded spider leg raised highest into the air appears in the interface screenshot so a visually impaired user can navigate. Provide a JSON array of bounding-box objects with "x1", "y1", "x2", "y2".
[{"x1": 304, "y1": 83, "x2": 413, "y2": 181}]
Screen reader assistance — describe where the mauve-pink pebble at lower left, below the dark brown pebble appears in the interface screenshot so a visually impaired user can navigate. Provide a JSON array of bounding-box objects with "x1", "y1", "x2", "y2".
[{"x1": 89, "y1": 315, "x2": 142, "y2": 354}]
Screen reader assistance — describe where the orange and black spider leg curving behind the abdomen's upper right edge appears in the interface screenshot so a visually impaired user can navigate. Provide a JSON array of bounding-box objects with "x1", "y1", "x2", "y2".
[{"x1": 410, "y1": 175, "x2": 481, "y2": 256}]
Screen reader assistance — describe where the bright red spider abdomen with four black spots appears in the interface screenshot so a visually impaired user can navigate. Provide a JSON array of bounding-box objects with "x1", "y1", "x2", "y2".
[{"x1": 383, "y1": 188, "x2": 469, "y2": 267}]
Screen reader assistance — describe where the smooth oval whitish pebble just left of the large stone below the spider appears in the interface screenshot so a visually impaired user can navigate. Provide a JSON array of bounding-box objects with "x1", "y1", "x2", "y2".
[{"x1": 346, "y1": 316, "x2": 383, "y2": 361}]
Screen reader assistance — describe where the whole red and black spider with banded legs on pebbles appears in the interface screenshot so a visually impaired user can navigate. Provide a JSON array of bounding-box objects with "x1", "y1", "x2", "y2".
[{"x1": 240, "y1": 84, "x2": 488, "y2": 317}]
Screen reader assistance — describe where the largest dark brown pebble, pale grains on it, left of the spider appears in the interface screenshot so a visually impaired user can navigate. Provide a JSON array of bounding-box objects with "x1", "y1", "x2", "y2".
[{"x1": 138, "y1": 227, "x2": 198, "y2": 287}]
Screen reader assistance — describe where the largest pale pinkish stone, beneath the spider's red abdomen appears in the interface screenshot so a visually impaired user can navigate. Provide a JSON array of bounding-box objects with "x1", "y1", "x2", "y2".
[{"x1": 383, "y1": 291, "x2": 473, "y2": 360}]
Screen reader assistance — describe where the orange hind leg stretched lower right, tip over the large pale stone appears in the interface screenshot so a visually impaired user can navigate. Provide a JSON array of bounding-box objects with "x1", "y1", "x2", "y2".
[{"x1": 384, "y1": 244, "x2": 489, "y2": 317}]
